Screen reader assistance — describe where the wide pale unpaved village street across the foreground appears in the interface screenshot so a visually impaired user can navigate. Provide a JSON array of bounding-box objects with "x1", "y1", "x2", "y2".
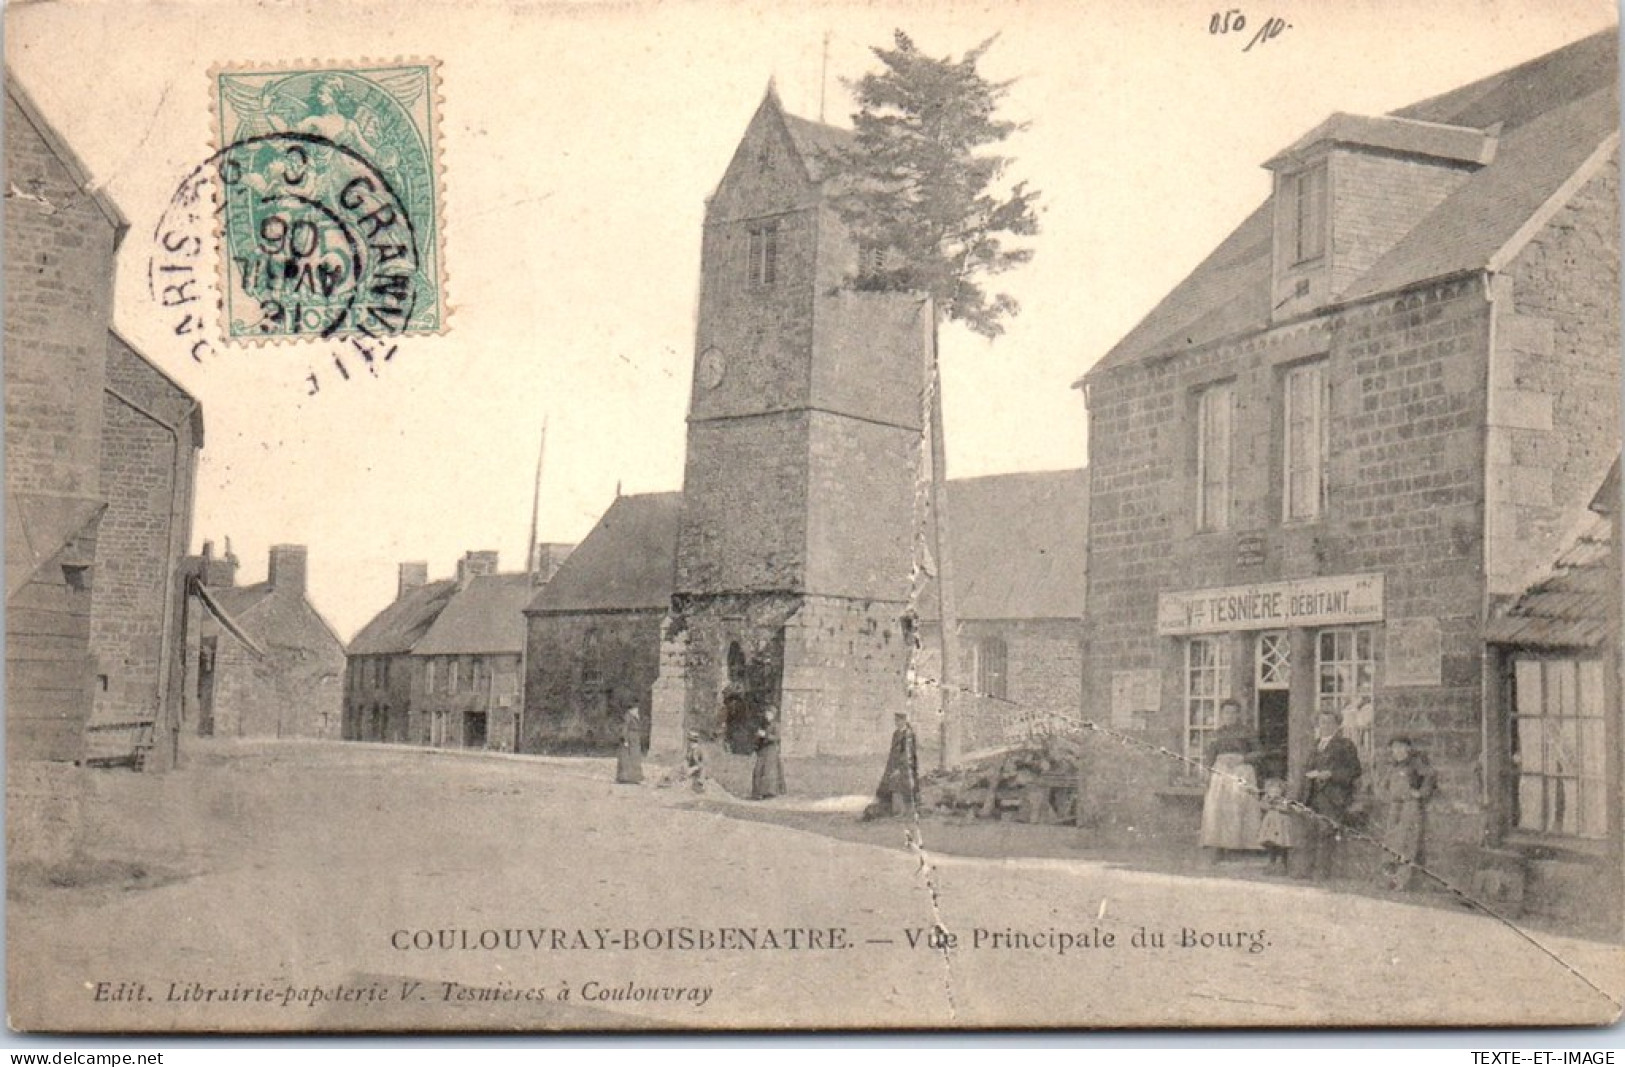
[{"x1": 8, "y1": 742, "x2": 1625, "y2": 1030}]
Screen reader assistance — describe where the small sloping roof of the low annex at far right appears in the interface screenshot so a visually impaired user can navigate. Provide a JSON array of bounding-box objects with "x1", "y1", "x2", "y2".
[{"x1": 1485, "y1": 515, "x2": 1619, "y2": 648}]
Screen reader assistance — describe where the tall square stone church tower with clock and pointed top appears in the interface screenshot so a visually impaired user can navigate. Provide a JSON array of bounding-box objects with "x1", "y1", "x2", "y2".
[{"x1": 653, "y1": 88, "x2": 930, "y2": 755}]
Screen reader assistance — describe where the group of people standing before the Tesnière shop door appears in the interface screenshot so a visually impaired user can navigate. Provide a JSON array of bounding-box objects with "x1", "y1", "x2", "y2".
[{"x1": 1201, "y1": 700, "x2": 1438, "y2": 890}]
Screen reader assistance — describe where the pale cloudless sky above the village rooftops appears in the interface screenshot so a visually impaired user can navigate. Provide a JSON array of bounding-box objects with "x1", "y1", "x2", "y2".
[{"x1": 5, "y1": 0, "x2": 1617, "y2": 638}]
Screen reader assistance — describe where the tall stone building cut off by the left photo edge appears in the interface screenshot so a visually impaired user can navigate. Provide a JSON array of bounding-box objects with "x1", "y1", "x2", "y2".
[{"x1": 5, "y1": 71, "x2": 203, "y2": 773}]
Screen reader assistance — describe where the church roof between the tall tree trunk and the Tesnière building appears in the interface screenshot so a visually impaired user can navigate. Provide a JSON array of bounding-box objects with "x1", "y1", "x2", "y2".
[{"x1": 920, "y1": 469, "x2": 1089, "y2": 619}]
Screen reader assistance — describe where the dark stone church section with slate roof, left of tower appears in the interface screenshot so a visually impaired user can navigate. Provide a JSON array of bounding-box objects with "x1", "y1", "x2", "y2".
[{"x1": 522, "y1": 492, "x2": 683, "y2": 752}]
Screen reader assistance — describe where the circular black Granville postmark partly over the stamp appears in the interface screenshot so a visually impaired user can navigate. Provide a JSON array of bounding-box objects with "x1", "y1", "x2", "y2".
[{"x1": 148, "y1": 132, "x2": 424, "y2": 388}]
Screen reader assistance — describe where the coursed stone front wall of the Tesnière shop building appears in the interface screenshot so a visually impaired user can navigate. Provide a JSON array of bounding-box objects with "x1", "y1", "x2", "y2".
[{"x1": 1084, "y1": 278, "x2": 1490, "y2": 843}]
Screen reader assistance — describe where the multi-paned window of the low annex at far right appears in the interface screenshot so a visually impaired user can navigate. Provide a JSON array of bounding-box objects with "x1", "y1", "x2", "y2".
[{"x1": 1511, "y1": 658, "x2": 1607, "y2": 838}]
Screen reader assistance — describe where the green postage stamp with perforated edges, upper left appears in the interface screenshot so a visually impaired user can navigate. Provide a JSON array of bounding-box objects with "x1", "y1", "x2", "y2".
[{"x1": 213, "y1": 60, "x2": 447, "y2": 344}]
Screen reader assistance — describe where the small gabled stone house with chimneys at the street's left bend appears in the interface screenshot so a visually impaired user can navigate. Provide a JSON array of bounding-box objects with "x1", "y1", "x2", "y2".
[{"x1": 187, "y1": 541, "x2": 345, "y2": 739}]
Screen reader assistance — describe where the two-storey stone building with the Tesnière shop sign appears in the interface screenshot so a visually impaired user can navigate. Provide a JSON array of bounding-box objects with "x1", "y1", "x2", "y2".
[{"x1": 1079, "y1": 32, "x2": 1620, "y2": 872}]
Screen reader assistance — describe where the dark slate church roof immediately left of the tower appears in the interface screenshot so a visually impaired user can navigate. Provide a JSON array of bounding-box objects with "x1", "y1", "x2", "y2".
[{"x1": 525, "y1": 492, "x2": 683, "y2": 614}]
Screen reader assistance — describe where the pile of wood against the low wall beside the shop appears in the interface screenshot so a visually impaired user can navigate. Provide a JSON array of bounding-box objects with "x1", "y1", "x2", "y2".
[{"x1": 920, "y1": 737, "x2": 1079, "y2": 823}]
